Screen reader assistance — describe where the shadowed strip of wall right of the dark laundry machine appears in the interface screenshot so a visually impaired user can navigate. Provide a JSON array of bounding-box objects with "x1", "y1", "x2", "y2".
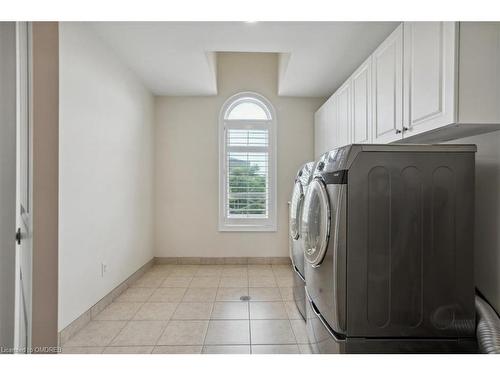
[{"x1": 450, "y1": 131, "x2": 500, "y2": 312}]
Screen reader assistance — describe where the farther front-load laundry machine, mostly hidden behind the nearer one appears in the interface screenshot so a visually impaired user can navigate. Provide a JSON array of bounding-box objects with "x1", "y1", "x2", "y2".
[{"x1": 289, "y1": 162, "x2": 314, "y2": 320}]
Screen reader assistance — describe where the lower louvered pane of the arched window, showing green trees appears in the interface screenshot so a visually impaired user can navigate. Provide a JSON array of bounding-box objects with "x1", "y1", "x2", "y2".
[{"x1": 226, "y1": 152, "x2": 269, "y2": 218}]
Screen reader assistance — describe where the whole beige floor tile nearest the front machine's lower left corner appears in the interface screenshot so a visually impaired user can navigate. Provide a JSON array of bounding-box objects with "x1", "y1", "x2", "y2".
[{"x1": 250, "y1": 319, "x2": 296, "y2": 345}]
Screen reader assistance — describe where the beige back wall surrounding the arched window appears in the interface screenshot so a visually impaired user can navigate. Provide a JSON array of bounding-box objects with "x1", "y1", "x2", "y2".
[{"x1": 155, "y1": 53, "x2": 324, "y2": 257}]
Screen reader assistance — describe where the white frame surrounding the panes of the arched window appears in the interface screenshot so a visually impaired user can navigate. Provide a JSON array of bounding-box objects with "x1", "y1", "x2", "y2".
[{"x1": 219, "y1": 92, "x2": 278, "y2": 232}]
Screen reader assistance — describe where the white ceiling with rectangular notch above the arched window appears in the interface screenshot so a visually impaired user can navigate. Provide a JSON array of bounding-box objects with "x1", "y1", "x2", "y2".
[{"x1": 89, "y1": 22, "x2": 398, "y2": 97}]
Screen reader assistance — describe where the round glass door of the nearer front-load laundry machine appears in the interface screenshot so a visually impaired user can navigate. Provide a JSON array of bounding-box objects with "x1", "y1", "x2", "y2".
[{"x1": 302, "y1": 178, "x2": 330, "y2": 267}]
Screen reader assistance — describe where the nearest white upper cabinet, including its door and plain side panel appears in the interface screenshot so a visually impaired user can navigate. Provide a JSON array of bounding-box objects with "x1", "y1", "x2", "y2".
[{"x1": 403, "y1": 22, "x2": 500, "y2": 143}]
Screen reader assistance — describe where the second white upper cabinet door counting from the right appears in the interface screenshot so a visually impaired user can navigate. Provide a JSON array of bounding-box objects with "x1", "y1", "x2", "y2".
[{"x1": 372, "y1": 24, "x2": 403, "y2": 143}]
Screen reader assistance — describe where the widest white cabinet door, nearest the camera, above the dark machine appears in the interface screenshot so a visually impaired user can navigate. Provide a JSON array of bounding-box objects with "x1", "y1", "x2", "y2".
[{"x1": 403, "y1": 22, "x2": 458, "y2": 137}]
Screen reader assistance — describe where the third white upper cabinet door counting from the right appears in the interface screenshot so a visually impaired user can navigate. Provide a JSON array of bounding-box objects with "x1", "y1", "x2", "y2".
[{"x1": 351, "y1": 57, "x2": 372, "y2": 143}]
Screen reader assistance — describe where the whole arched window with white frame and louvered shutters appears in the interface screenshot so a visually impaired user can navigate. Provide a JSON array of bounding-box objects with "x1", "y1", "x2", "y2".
[{"x1": 219, "y1": 92, "x2": 277, "y2": 231}]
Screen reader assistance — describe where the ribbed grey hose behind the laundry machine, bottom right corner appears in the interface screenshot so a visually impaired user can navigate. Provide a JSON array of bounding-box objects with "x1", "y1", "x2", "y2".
[{"x1": 476, "y1": 296, "x2": 500, "y2": 354}]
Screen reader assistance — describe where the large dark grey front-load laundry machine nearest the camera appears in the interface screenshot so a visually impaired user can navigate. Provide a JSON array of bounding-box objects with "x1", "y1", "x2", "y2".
[{"x1": 301, "y1": 144, "x2": 476, "y2": 353}]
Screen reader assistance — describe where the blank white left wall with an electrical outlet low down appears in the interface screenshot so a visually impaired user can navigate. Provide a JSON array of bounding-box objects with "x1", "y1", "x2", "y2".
[{"x1": 59, "y1": 23, "x2": 154, "y2": 329}]
